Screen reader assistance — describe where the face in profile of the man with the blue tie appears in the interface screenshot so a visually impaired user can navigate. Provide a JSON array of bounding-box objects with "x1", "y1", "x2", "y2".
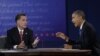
[{"x1": 72, "y1": 14, "x2": 82, "y2": 27}]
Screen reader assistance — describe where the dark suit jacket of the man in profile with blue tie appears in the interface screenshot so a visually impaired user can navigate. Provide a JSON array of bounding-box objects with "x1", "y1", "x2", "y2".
[{"x1": 68, "y1": 21, "x2": 96, "y2": 49}]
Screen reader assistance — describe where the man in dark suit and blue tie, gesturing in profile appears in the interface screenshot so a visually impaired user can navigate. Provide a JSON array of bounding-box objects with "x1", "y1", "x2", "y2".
[{"x1": 56, "y1": 10, "x2": 97, "y2": 55}]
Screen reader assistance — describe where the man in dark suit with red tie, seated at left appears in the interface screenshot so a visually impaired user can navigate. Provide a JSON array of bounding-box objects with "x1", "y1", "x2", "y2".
[{"x1": 5, "y1": 13, "x2": 39, "y2": 49}]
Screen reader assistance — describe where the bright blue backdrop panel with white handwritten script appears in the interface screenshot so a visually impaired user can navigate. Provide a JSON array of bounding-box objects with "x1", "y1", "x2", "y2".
[{"x1": 0, "y1": 0, "x2": 66, "y2": 47}]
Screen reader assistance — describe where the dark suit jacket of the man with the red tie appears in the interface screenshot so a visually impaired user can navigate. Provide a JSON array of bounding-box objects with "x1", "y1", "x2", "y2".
[{"x1": 5, "y1": 27, "x2": 34, "y2": 49}]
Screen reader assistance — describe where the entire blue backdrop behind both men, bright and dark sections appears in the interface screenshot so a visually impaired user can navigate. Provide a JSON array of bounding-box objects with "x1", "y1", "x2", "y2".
[{"x1": 0, "y1": 0, "x2": 100, "y2": 47}]
